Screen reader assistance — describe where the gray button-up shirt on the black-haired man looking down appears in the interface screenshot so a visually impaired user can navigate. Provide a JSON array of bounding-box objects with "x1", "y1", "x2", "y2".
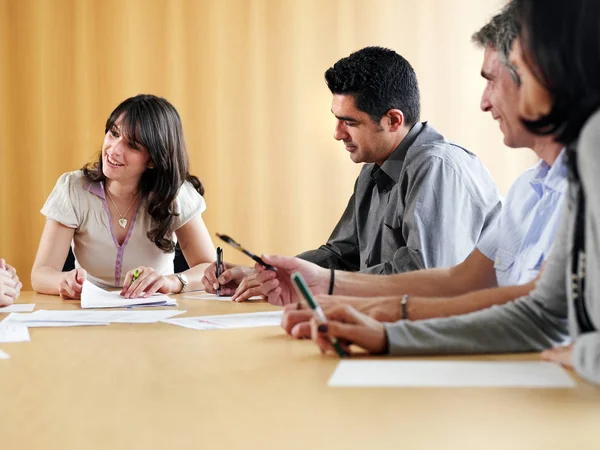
[{"x1": 298, "y1": 122, "x2": 501, "y2": 274}]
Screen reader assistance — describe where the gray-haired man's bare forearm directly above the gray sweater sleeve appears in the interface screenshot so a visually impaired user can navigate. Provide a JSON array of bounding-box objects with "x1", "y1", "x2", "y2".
[{"x1": 407, "y1": 281, "x2": 535, "y2": 320}]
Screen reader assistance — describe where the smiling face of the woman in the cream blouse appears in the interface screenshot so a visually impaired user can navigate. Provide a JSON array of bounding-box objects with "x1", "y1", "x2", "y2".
[{"x1": 102, "y1": 118, "x2": 150, "y2": 184}]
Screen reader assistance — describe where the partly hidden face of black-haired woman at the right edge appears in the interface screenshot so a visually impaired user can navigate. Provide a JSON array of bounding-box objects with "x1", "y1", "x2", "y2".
[{"x1": 510, "y1": 38, "x2": 552, "y2": 120}]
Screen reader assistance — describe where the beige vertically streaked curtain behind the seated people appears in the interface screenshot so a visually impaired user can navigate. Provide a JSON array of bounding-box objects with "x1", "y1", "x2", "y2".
[{"x1": 0, "y1": 0, "x2": 534, "y2": 287}]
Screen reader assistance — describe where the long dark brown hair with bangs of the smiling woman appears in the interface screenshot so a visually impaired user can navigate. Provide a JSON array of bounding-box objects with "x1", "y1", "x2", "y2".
[{"x1": 83, "y1": 95, "x2": 204, "y2": 253}]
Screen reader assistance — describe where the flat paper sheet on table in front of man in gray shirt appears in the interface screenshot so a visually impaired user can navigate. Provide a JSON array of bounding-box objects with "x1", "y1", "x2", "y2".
[{"x1": 163, "y1": 311, "x2": 283, "y2": 330}]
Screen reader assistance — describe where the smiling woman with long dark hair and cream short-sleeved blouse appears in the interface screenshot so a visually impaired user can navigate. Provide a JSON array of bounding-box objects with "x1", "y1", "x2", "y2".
[{"x1": 31, "y1": 95, "x2": 214, "y2": 298}]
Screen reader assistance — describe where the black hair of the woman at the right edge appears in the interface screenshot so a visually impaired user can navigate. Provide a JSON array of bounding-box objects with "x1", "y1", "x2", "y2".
[{"x1": 516, "y1": 0, "x2": 600, "y2": 145}]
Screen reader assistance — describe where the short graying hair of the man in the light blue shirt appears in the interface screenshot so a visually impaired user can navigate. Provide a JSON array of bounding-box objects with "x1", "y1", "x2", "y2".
[{"x1": 471, "y1": 1, "x2": 520, "y2": 84}]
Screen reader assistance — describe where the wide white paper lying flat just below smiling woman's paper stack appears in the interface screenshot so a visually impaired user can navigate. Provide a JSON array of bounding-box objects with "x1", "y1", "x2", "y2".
[{"x1": 2, "y1": 309, "x2": 186, "y2": 327}]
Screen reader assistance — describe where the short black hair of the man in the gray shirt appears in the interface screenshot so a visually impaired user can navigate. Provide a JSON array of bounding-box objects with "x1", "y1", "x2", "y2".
[{"x1": 325, "y1": 47, "x2": 421, "y2": 126}]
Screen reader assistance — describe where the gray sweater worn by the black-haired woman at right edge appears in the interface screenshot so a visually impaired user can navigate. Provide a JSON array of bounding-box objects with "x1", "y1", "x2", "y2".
[{"x1": 385, "y1": 112, "x2": 600, "y2": 384}]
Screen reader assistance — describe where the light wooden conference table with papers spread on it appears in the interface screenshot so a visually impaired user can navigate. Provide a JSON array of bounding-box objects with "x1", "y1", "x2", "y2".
[{"x1": 0, "y1": 292, "x2": 600, "y2": 450}]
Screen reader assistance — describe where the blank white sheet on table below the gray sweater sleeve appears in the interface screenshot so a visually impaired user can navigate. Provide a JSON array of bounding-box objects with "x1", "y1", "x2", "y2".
[{"x1": 328, "y1": 360, "x2": 575, "y2": 388}]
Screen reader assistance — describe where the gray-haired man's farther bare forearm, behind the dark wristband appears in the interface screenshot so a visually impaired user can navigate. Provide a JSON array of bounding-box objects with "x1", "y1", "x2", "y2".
[{"x1": 333, "y1": 268, "x2": 470, "y2": 297}]
